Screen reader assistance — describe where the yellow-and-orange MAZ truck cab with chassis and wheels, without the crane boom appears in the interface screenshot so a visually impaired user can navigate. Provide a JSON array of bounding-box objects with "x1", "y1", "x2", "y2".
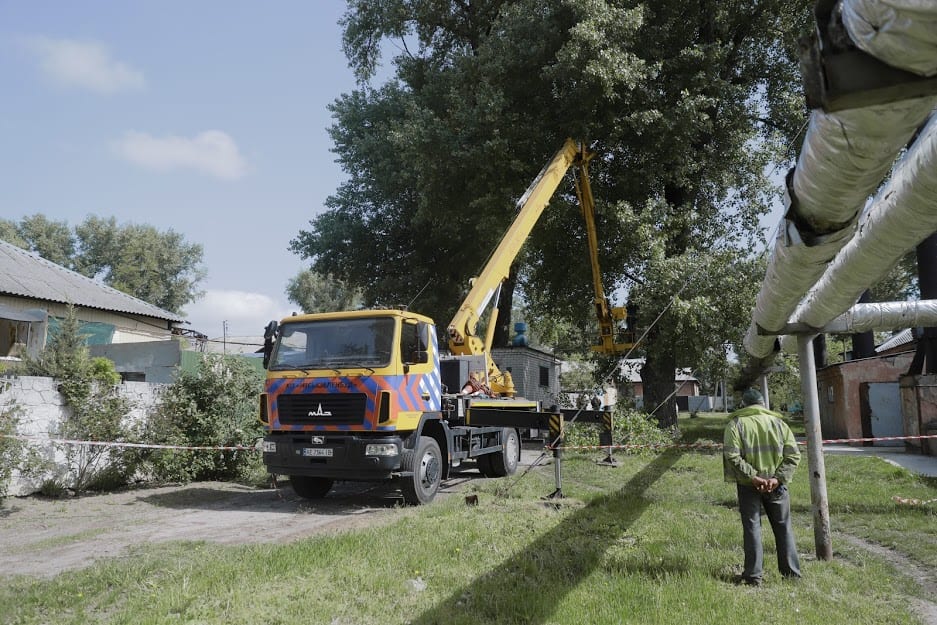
[{"x1": 260, "y1": 310, "x2": 520, "y2": 503}]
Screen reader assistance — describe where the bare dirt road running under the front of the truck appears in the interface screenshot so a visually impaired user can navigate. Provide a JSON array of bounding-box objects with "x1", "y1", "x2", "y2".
[{"x1": 0, "y1": 471, "x2": 482, "y2": 577}]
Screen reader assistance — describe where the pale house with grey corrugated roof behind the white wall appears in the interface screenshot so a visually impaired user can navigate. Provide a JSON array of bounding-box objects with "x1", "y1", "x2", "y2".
[{"x1": 0, "y1": 241, "x2": 185, "y2": 359}]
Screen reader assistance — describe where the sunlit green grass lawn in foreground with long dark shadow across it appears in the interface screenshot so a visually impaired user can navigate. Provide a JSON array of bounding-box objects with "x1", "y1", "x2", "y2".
[{"x1": 0, "y1": 415, "x2": 937, "y2": 625}]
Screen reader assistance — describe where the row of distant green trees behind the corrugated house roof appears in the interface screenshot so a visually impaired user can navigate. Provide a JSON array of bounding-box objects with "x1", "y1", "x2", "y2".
[{"x1": 0, "y1": 215, "x2": 205, "y2": 312}]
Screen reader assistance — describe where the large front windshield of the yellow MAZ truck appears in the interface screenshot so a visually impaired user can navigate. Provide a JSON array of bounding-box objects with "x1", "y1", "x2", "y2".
[{"x1": 268, "y1": 317, "x2": 394, "y2": 370}]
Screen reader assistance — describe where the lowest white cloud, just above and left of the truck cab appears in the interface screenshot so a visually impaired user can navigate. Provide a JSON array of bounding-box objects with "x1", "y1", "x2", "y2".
[{"x1": 183, "y1": 290, "x2": 290, "y2": 338}]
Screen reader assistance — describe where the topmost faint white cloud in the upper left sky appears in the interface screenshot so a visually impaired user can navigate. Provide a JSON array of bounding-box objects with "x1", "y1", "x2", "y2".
[{"x1": 27, "y1": 37, "x2": 146, "y2": 93}]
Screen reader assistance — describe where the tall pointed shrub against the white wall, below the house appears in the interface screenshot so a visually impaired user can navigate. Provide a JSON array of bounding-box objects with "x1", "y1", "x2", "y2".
[{"x1": 23, "y1": 306, "x2": 135, "y2": 493}]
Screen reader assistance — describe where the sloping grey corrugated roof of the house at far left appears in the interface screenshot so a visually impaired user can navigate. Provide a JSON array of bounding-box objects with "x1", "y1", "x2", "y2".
[{"x1": 0, "y1": 241, "x2": 185, "y2": 322}]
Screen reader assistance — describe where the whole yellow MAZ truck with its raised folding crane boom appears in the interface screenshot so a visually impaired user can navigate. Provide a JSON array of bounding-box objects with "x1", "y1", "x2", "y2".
[{"x1": 260, "y1": 139, "x2": 632, "y2": 504}]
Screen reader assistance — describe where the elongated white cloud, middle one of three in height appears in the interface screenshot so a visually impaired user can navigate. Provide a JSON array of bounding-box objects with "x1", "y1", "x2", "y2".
[{"x1": 111, "y1": 130, "x2": 247, "y2": 180}]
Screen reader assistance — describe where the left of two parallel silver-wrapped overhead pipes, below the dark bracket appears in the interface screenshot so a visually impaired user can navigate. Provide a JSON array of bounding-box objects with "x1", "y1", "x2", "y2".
[{"x1": 745, "y1": 97, "x2": 937, "y2": 358}]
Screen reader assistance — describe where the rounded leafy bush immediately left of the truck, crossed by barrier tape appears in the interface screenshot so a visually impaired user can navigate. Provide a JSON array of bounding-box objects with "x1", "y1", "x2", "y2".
[{"x1": 144, "y1": 355, "x2": 263, "y2": 482}]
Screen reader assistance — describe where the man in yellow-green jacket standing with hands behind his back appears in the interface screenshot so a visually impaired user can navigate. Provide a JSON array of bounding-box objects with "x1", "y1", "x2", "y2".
[{"x1": 722, "y1": 388, "x2": 800, "y2": 586}]
